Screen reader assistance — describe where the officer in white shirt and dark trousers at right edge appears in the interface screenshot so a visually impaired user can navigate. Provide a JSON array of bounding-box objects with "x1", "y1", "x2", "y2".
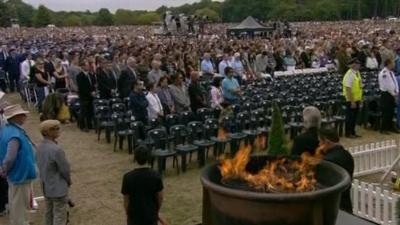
[{"x1": 379, "y1": 59, "x2": 399, "y2": 134}]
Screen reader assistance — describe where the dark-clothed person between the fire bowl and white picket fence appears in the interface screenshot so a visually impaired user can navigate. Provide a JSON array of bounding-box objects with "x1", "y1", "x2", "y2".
[{"x1": 319, "y1": 129, "x2": 354, "y2": 213}]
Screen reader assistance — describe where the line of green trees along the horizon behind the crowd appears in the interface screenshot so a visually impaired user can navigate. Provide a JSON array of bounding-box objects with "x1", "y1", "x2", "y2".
[{"x1": 0, "y1": 0, "x2": 400, "y2": 27}]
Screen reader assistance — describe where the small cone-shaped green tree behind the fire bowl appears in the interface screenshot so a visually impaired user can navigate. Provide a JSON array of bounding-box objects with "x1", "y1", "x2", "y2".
[{"x1": 267, "y1": 102, "x2": 289, "y2": 156}]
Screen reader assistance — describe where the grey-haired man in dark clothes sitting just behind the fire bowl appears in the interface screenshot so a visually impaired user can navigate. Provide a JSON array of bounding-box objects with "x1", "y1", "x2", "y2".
[{"x1": 292, "y1": 106, "x2": 321, "y2": 156}]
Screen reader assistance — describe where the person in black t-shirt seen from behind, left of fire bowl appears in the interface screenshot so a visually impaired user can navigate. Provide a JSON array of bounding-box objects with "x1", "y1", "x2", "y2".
[{"x1": 121, "y1": 146, "x2": 165, "y2": 225}]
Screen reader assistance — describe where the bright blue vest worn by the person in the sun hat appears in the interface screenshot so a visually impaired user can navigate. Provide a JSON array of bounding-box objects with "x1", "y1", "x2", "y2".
[{"x1": 0, "y1": 124, "x2": 36, "y2": 184}]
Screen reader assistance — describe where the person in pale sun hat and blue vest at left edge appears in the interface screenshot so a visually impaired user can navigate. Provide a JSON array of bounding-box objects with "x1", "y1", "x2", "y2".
[{"x1": 0, "y1": 104, "x2": 36, "y2": 225}]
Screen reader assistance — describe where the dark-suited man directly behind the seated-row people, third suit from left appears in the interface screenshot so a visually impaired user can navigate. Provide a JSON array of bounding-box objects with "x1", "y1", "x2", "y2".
[{"x1": 118, "y1": 57, "x2": 137, "y2": 99}]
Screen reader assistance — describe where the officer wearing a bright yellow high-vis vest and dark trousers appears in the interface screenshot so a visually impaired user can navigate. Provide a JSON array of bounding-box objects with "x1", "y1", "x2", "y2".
[{"x1": 343, "y1": 59, "x2": 363, "y2": 138}]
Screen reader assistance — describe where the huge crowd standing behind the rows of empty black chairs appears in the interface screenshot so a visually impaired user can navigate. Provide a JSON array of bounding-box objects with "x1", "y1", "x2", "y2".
[{"x1": 0, "y1": 21, "x2": 400, "y2": 128}]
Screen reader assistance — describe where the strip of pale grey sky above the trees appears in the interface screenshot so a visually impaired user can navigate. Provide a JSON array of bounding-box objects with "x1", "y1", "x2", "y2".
[{"x1": 23, "y1": 0, "x2": 217, "y2": 12}]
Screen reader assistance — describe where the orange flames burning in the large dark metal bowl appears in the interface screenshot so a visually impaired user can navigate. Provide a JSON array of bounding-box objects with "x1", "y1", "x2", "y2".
[{"x1": 219, "y1": 143, "x2": 325, "y2": 193}]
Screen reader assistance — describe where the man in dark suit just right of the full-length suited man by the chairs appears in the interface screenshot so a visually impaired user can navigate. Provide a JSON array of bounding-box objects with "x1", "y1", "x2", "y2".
[{"x1": 96, "y1": 59, "x2": 117, "y2": 99}]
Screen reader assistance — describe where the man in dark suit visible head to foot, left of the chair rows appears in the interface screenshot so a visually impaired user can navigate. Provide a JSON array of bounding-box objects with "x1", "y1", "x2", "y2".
[{"x1": 76, "y1": 60, "x2": 96, "y2": 132}]
